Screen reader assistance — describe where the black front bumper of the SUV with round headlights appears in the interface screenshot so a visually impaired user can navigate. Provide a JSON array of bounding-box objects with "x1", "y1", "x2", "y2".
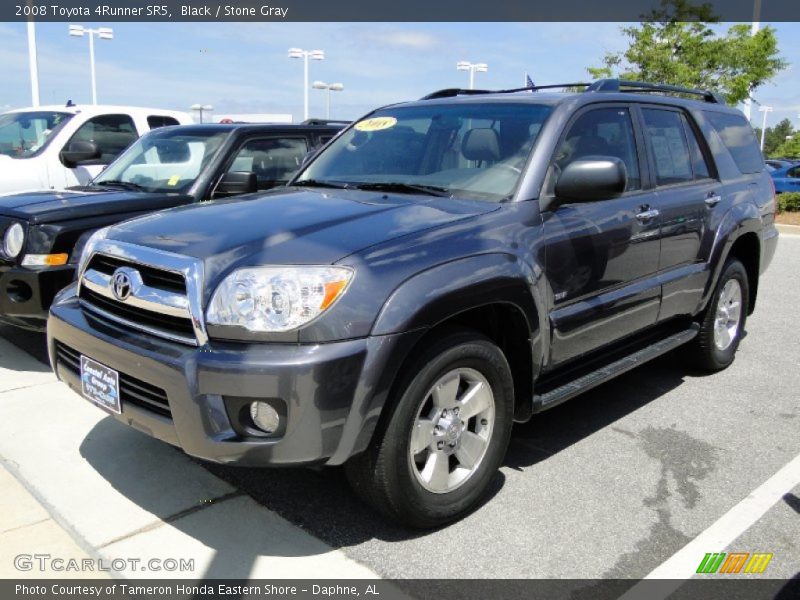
[{"x1": 0, "y1": 265, "x2": 75, "y2": 331}]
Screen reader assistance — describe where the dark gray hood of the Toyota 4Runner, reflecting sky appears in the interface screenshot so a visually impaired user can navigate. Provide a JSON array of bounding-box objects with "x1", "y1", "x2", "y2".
[{"x1": 107, "y1": 189, "x2": 498, "y2": 279}]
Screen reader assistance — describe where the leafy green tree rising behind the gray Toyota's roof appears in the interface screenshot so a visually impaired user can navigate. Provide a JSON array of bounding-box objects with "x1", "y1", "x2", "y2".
[{"x1": 588, "y1": 0, "x2": 787, "y2": 104}]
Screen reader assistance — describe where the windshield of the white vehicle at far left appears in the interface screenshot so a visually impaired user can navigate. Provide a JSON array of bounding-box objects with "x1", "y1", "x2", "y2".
[{"x1": 0, "y1": 111, "x2": 72, "y2": 158}]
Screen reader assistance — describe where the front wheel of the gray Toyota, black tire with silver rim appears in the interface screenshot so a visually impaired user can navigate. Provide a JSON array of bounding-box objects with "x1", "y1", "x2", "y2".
[{"x1": 346, "y1": 331, "x2": 514, "y2": 529}]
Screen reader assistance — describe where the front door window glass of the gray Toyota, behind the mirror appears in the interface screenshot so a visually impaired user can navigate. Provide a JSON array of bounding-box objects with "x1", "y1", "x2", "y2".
[{"x1": 555, "y1": 108, "x2": 641, "y2": 190}]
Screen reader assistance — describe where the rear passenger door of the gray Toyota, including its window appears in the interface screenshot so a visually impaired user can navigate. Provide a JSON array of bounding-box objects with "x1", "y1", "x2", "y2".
[{"x1": 641, "y1": 105, "x2": 724, "y2": 320}]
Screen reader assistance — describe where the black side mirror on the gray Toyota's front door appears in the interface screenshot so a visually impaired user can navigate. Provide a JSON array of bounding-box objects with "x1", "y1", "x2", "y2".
[{"x1": 550, "y1": 156, "x2": 628, "y2": 208}]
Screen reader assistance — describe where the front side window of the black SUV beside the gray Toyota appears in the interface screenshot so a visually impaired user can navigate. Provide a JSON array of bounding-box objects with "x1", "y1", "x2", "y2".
[{"x1": 228, "y1": 138, "x2": 308, "y2": 190}]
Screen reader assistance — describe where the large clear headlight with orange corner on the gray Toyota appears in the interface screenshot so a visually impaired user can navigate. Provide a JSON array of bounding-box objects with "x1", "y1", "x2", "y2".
[{"x1": 206, "y1": 267, "x2": 353, "y2": 333}]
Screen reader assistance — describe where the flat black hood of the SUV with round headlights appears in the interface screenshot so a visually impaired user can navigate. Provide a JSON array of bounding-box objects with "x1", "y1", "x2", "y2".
[{"x1": 0, "y1": 188, "x2": 190, "y2": 223}]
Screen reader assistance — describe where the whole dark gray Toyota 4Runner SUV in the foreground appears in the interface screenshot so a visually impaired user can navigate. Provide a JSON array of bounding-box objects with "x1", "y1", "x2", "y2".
[{"x1": 48, "y1": 80, "x2": 777, "y2": 527}]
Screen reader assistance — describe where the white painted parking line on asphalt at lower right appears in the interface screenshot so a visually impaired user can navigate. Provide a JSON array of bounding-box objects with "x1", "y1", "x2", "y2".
[{"x1": 622, "y1": 455, "x2": 800, "y2": 598}]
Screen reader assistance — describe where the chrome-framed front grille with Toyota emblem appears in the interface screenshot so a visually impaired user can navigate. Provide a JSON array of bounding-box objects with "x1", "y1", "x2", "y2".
[{"x1": 78, "y1": 240, "x2": 207, "y2": 345}]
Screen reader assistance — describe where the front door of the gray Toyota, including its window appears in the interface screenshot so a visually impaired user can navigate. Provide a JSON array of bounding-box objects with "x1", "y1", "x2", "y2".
[{"x1": 543, "y1": 104, "x2": 661, "y2": 368}]
